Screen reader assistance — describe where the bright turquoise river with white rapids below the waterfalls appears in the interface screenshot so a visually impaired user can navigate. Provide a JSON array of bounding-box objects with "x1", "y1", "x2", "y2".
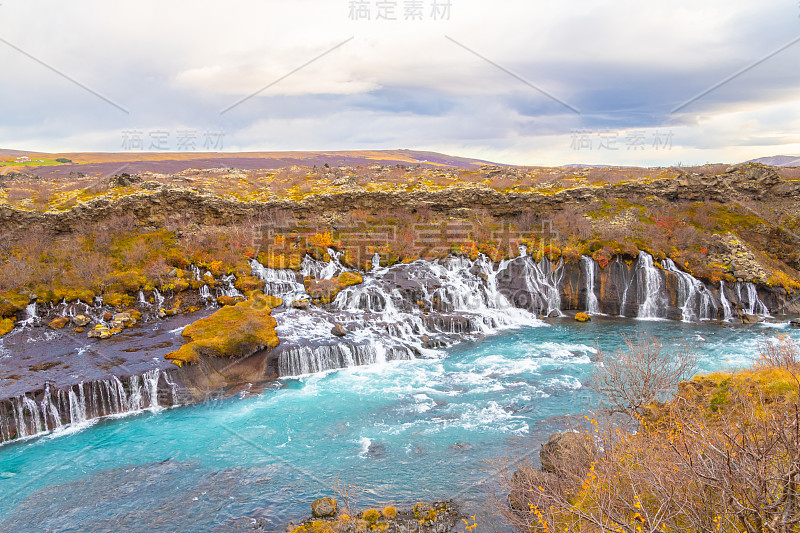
[{"x1": 0, "y1": 319, "x2": 800, "y2": 531}]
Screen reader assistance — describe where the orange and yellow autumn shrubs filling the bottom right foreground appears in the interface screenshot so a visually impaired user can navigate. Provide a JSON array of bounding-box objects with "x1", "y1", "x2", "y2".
[{"x1": 493, "y1": 338, "x2": 800, "y2": 533}]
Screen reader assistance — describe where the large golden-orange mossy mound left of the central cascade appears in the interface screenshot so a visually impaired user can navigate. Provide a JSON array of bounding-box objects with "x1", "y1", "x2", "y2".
[{"x1": 164, "y1": 291, "x2": 281, "y2": 366}]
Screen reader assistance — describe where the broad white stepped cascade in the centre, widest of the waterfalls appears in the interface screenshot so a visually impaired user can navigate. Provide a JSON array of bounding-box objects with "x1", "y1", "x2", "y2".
[{"x1": 276, "y1": 254, "x2": 542, "y2": 376}]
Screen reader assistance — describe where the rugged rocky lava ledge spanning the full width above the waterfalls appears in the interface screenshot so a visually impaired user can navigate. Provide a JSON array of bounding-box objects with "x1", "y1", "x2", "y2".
[{"x1": 0, "y1": 165, "x2": 800, "y2": 232}]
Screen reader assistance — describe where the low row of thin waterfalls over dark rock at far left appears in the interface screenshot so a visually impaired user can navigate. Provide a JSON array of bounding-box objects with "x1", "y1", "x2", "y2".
[{"x1": 0, "y1": 369, "x2": 178, "y2": 442}]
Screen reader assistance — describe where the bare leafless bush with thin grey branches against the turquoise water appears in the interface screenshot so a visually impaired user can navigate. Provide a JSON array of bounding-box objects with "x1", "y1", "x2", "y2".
[{"x1": 590, "y1": 335, "x2": 697, "y2": 415}]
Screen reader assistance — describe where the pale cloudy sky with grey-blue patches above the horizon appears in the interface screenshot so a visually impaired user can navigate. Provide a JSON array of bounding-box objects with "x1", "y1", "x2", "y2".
[{"x1": 0, "y1": 0, "x2": 800, "y2": 165}]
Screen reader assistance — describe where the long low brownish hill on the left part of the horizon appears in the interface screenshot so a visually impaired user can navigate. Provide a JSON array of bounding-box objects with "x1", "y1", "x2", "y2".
[{"x1": 0, "y1": 149, "x2": 495, "y2": 177}]
